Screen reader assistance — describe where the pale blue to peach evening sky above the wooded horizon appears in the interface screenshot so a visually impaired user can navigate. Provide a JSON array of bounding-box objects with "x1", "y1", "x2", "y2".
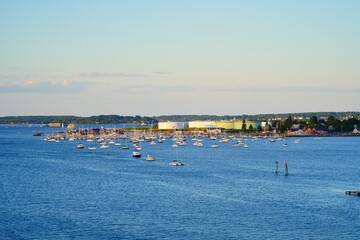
[{"x1": 0, "y1": 0, "x2": 360, "y2": 116}]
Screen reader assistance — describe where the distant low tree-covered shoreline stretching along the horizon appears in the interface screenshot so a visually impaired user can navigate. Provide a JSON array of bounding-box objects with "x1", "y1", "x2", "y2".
[{"x1": 0, "y1": 112, "x2": 360, "y2": 124}]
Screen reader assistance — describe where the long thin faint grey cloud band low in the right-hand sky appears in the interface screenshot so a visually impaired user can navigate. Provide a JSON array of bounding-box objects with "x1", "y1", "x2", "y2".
[{"x1": 212, "y1": 87, "x2": 360, "y2": 93}]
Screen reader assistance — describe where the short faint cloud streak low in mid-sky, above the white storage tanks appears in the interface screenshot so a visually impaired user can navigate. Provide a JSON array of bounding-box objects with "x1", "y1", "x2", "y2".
[{"x1": 119, "y1": 85, "x2": 195, "y2": 94}]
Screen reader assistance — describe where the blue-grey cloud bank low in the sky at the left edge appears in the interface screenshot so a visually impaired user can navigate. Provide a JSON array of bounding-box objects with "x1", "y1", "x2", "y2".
[{"x1": 0, "y1": 80, "x2": 92, "y2": 93}]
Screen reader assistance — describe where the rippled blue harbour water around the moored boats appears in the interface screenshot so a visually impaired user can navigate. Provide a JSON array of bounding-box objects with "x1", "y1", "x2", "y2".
[{"x1": 0, "y1": 126, "x2": 360, "y2": 239}]
